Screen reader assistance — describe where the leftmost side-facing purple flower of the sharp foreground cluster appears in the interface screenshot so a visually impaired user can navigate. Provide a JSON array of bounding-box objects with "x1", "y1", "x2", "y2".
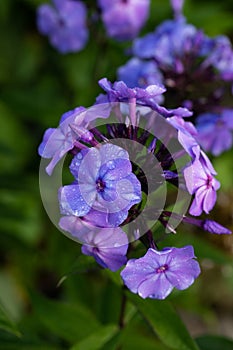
[{"x1": 38, "y1": 107, "x2": 85, "y2": 175}]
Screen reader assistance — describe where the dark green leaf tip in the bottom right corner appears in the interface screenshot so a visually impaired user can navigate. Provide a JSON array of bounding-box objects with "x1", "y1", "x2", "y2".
[{"x1": 196, "y1": 335, "x2": 233, "y2": 350}]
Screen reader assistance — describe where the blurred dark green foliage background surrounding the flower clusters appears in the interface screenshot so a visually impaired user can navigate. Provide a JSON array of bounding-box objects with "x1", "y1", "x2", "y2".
[{"x1": 0, "y1": 0, "x2": 233, "y2": 350}]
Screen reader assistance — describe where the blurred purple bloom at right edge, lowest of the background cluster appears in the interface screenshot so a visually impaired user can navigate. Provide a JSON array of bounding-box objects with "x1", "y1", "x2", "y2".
[{"x1": 196, "y1": 109, "x2": 233, "y2": 156}]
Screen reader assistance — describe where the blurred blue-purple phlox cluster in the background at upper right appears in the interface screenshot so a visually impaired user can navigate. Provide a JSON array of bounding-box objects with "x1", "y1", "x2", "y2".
[{"x1": 118, "y1": 0, "x2": 233, "y2": 156}]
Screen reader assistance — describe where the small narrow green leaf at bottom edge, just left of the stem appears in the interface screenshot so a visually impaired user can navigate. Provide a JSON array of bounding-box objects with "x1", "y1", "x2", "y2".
[{"x1": 71, "y1": 325, "x2": 118, "y2": 350}]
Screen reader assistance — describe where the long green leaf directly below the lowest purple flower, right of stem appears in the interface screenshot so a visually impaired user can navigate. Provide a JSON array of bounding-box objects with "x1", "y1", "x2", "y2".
[{"x1": 127, "y1": 293, "x2": 198, "y2": 350}]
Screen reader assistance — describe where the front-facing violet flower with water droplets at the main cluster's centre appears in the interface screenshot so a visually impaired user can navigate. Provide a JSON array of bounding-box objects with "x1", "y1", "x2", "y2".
[{"x1": 59, "y1": 144, "x2": 141, "y2": 227}]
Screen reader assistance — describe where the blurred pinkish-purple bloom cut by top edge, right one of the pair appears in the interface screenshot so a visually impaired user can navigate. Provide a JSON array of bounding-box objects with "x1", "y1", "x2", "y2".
[{"x1": 98, "y1": 0, "x2": 150, "y2": 41}]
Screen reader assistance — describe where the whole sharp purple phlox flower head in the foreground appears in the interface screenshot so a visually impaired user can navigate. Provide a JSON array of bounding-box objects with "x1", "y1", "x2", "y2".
[{"x1": 39, "y1": 78, "x2": 230, "y2": 299}]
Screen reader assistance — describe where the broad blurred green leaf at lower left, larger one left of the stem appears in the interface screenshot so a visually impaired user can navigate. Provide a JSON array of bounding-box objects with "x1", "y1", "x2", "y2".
[{"x1": 32, "y1": 294, "x2": 100, "y2": 343}]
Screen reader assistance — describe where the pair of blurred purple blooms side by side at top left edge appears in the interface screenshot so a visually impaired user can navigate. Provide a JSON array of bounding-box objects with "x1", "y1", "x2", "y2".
[{"x1": 37, "y1": 0, "x2": 150, "y2": 54}]
